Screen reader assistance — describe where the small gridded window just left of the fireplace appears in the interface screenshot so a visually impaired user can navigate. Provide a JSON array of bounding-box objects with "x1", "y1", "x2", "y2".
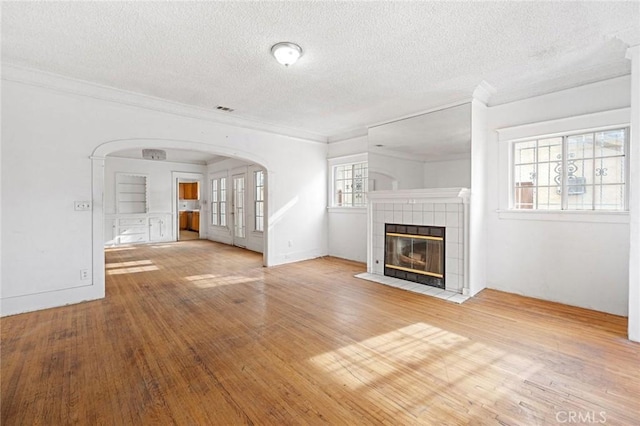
[{"x1": 333, "y1": 162, "x2": 368, "y2": 207}]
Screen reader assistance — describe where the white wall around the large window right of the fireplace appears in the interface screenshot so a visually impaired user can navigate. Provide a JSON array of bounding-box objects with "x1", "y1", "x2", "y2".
[{"x1": 486, "y1": 77, "x2": 638, "y2": 315}]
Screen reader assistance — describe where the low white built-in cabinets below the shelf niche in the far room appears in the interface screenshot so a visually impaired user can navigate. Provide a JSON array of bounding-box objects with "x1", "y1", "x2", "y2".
[{"x1": 104, "y1": 213, "x2": 173, "y2": 245}]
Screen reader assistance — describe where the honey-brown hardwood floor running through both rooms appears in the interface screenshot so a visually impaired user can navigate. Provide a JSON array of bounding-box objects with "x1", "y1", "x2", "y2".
[{"x1": 1, "y1": 240, "x2": 640, "y2": 425}]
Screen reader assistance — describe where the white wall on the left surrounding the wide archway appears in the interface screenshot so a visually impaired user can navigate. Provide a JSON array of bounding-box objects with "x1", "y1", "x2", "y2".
[{"x1": 1, "y1": 68, "x2": 328, "y2": 315}]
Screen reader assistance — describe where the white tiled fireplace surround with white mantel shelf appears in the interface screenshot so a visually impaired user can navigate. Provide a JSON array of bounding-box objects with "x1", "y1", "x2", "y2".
[{"x1": 367, "y1": 188, "x2": 469, "y2": 295}]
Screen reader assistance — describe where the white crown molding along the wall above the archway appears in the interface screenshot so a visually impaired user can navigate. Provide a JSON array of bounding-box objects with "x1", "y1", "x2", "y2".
[{"x1": 2, "y1": 63, "x2": 328, "y2": 144}]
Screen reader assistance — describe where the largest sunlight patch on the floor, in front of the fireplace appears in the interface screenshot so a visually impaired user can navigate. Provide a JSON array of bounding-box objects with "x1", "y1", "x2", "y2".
[{"x1": 309, "y1": 322, "x2": 541, "y2": 418}]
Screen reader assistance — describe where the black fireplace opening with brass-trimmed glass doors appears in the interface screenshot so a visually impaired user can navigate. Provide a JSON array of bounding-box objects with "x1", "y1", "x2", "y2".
[{"x1": 384, "y1": 223, "x2": 445, "y2": 288}]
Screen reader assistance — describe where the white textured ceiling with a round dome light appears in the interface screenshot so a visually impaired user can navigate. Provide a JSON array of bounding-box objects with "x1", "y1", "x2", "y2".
[{"x1": 2, "y1": 1, "x2": 640, "y2": 138}]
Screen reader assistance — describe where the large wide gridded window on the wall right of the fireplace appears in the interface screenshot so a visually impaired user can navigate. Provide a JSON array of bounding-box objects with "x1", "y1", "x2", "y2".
[{"x1": 512, "y1": 128, "x2": 629, "y2": 211}]
